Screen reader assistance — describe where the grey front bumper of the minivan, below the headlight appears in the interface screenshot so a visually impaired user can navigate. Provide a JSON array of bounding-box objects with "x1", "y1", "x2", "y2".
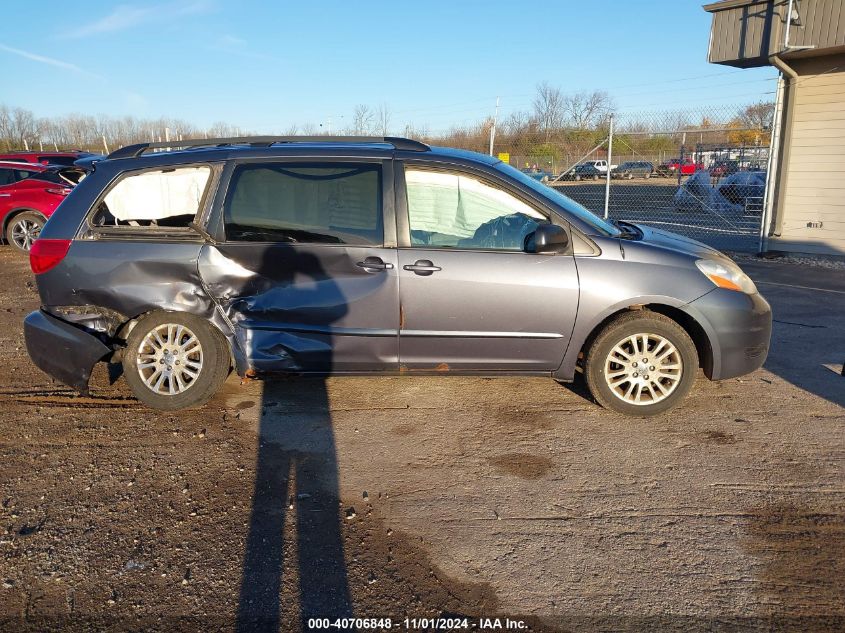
[{"x1": 686, "y1": 288, "x2": 772, "y2": 380}]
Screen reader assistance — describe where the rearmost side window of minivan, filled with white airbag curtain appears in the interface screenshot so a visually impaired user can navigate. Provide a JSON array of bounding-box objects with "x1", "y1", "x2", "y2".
[{"x1": 93, "y1": 166, "x2": 211, "y2": 227}]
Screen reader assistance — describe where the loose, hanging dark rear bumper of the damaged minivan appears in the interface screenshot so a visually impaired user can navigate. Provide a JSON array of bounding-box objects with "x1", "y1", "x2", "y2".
[{"x1": 23, "y1": 310, "x2": 112, "y2": 393}]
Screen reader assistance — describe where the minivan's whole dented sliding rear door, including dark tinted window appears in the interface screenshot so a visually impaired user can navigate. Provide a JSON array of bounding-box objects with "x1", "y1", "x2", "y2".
[{"x1": 199, "y1": 161, "x2": 399, "y2": 373}]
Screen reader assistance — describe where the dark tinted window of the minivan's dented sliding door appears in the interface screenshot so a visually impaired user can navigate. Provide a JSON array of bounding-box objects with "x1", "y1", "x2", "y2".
[{"x1": 224, "y1": 163, "x2": 384, "y2": 246}]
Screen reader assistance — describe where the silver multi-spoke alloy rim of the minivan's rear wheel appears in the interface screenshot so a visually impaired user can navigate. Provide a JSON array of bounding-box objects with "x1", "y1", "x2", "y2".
[{"x1": 137, "y1": 323, "x2": 203, "y2": 396}]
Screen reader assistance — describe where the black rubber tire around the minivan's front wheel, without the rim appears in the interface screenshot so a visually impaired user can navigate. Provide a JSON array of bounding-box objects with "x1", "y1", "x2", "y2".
[{"x1": 584, "y1": 310, "x2": 698, "y2": 417}]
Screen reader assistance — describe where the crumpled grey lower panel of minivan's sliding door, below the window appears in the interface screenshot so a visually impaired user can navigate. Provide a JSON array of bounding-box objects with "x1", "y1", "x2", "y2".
[{"x1": 199, "y1": 243, "x2": 399, "y2": 373}]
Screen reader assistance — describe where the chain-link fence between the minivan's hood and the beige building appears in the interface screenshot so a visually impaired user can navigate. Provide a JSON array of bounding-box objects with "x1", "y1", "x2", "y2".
[{"x1": 431, "y1": 103, "x2": 773, "y2": 251}]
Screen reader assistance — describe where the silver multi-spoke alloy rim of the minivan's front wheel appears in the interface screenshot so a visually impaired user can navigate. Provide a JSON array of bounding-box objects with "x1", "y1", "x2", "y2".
[{"x1": 604, "y1": 333, "x2": 684, "y2": 406}]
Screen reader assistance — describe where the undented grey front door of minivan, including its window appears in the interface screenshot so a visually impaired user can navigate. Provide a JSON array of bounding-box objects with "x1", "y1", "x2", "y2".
[{"x1": 397, "y1": 164, "x2": 578, "y2": 372}]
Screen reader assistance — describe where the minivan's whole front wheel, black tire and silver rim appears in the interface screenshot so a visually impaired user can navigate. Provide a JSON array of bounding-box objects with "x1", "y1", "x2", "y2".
[{"x1": 584, "y1": 310, "x2": 698, "y2": 417}]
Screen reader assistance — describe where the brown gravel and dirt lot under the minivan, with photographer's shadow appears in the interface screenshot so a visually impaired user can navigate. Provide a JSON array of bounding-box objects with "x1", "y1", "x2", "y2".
[{"x1": 0, "y1": 247, "x2": 845, "y2": 631}]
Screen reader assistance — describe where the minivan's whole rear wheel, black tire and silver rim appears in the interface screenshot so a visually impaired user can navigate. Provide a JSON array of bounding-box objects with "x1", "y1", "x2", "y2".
[{"x1": 123, "y1": 312, "x2": 230, "y2": 410}]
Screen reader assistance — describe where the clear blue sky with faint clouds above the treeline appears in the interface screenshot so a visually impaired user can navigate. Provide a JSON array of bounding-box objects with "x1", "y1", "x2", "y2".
[{"x1": 0, "y1": 0, "x2": 775, "y2": 133}]
